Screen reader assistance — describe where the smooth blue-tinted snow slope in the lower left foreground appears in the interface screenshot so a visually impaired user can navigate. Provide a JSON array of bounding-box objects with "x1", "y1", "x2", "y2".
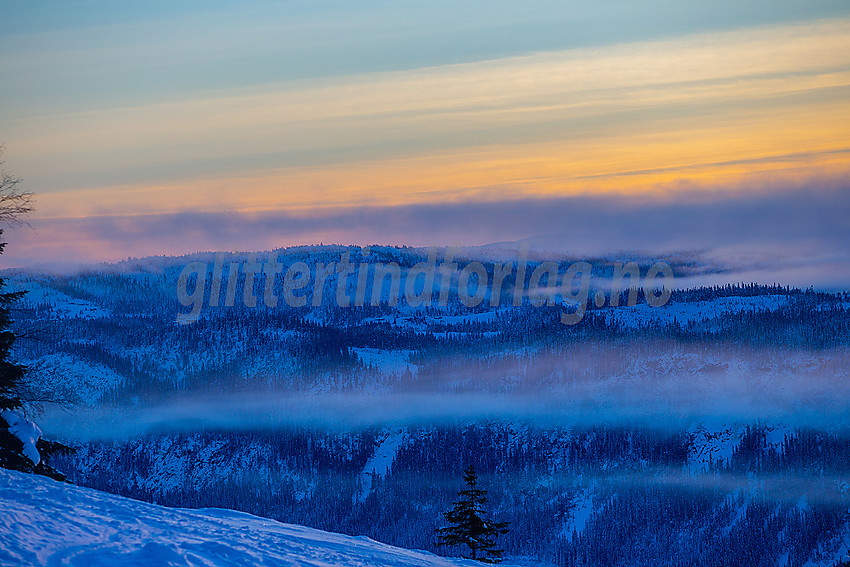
[{"x1": 0, "y1": 469, "x2": 490, "y2": 567}]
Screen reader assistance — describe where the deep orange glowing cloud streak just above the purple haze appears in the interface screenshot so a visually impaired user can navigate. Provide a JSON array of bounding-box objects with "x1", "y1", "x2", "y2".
[{"x1": 29, "y1": 92, "x2": 850, "y2": 217}]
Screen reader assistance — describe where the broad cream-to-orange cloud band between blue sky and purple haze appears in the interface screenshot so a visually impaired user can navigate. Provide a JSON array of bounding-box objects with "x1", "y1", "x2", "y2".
[{"x1": 4, "y1": 16, "x2": 850, "y2": 224}]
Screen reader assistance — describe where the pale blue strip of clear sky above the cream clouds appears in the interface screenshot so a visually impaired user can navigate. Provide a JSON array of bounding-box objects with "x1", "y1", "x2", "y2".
[{"x1": 6, "y1": 0, "x2": 850, "y2": 117}]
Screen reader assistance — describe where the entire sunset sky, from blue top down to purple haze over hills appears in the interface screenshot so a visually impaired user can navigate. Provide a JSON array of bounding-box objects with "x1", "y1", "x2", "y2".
[{"x1": 0, "y1": 0, "x2": 850, "y2": 287}]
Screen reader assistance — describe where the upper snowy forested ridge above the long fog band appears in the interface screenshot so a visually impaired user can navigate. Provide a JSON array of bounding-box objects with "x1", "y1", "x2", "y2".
[{"x1": 7, "y1": 247, "x2": 850, "y2": 400}]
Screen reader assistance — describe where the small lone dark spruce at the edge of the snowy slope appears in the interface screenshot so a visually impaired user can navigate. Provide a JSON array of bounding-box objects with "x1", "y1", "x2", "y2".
[{"x1": 437, "y1": 465, "x2": 508, "y2": 563}]
